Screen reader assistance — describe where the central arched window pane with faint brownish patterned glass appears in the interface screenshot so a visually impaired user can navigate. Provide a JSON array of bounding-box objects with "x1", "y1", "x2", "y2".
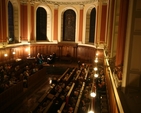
[{"x1": 63, "y1": 9, "x2": 76, "y2": 41}]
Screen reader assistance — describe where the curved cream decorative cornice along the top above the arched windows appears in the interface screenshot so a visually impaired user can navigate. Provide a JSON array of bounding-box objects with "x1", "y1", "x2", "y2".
[{"x1": 27, "y1": 0, "x2": 98, "y2": 5}]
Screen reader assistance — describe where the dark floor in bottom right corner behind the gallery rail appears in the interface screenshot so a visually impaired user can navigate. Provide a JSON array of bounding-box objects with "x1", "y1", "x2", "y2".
[{"x1": 117, "y1": 87, "x2": 141, "y2": 113}]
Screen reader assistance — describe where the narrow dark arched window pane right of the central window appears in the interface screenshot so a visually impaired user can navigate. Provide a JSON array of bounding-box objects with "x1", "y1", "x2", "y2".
[{"x1": 89, "y1": 8, "x2": 96, "y2": 43}]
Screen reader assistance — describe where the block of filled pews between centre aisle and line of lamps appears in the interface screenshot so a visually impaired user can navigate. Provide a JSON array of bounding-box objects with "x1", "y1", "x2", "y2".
[{"x1": 30, "y1": 64, "x2": 91, "y2": 113}]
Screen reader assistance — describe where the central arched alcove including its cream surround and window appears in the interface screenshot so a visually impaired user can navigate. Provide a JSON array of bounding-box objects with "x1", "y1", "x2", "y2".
[{"x1": 59, "y1": 7, "x2": 78, "y2": 42}]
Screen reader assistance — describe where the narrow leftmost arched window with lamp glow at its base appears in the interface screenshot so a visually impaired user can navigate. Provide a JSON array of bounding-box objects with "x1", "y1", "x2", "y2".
[{"x1": 8, "y1": 1, "x2": 14, "y2": 43}]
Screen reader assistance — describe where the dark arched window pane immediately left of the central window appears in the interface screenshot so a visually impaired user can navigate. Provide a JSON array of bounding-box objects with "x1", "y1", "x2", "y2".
[{"x1": 36, "y1": 7, "x2": 48, "y2": 41}]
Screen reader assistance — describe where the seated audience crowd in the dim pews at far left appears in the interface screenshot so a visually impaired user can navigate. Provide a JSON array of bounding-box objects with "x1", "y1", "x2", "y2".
[{"x1": 0, "y1": 60, "x2": 42, "y2": 93}]
